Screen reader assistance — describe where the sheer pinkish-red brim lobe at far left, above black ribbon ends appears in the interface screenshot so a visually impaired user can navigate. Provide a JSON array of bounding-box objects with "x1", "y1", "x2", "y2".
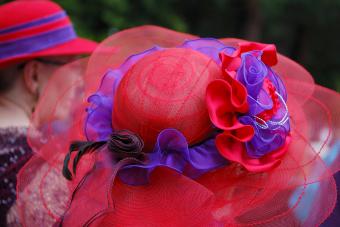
[{"x1": 28, "y1": 59, "x2": 88, "y2": 160}]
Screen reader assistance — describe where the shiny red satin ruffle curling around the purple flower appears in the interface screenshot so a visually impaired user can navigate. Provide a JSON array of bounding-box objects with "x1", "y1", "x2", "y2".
[{"x1": 206, "y1": 42, "x2": 290, "y2": 172}]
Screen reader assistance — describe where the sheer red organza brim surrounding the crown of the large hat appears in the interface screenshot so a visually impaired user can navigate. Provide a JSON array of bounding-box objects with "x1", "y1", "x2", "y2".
[{"x1": 17, "y1": 26, "x2": 340, "y2": 226}]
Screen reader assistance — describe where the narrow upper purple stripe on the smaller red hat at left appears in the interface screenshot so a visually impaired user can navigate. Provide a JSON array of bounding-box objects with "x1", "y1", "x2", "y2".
[{"x1": 0, "y1": 11, "x2": 66, "y2": 35}]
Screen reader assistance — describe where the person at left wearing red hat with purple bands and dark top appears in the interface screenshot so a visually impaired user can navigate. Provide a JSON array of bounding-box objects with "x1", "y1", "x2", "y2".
[{"x1": 0, "y1": 0, "x2": 97, "y2": 226}]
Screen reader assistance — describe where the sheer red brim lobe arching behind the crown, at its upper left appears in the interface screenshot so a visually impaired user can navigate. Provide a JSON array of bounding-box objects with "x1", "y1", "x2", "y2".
[{"x1": 85, "y1": 26, "x2": 198, "y2": 96}]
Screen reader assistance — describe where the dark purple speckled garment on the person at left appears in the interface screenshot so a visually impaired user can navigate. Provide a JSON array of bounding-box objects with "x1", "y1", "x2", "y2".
[{"x1": 0, "y1": 127, "x2": 32, "y2": 226}]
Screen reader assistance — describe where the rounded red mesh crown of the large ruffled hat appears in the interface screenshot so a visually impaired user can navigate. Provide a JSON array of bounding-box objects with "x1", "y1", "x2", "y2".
[{"x1": 112, "y1": 48, "x2": 222, "y2": 150}]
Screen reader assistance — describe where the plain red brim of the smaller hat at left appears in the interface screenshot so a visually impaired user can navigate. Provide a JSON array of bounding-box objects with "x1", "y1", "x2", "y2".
[{"x1": 0, "y1": 38, "x2": 98, "y2": 68}]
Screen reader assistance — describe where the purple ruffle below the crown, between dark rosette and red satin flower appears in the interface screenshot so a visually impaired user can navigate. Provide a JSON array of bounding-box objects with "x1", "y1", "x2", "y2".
[{"x1": 119, "y1": 129, "x2": 227, "y2": 185}]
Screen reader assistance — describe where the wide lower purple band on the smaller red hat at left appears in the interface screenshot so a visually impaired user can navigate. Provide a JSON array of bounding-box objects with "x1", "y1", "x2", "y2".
[{"x1": 0, "y1": 26, "x2": 77, "y2": 59}]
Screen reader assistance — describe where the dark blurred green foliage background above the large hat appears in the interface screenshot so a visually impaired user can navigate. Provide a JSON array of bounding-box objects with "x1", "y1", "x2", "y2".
[{"x1": 4, "y1": 0, "x2": 340, "y2": 91}]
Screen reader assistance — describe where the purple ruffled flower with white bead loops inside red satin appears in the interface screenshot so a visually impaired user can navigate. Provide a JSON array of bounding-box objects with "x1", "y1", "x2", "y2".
[{"x1": 237, "y1": 51, "x2": 290, "y2": 158}]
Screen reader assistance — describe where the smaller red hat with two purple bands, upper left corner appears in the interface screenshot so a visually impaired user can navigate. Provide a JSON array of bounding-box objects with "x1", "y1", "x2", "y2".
[{"x1": 0, "y1": 0, "x2": 97, "y2": 67}]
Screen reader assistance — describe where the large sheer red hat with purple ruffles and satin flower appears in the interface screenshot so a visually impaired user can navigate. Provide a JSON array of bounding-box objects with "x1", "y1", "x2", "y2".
[{"x1": 16, "y1": 26, "x2": 340, "y2": 227}]
